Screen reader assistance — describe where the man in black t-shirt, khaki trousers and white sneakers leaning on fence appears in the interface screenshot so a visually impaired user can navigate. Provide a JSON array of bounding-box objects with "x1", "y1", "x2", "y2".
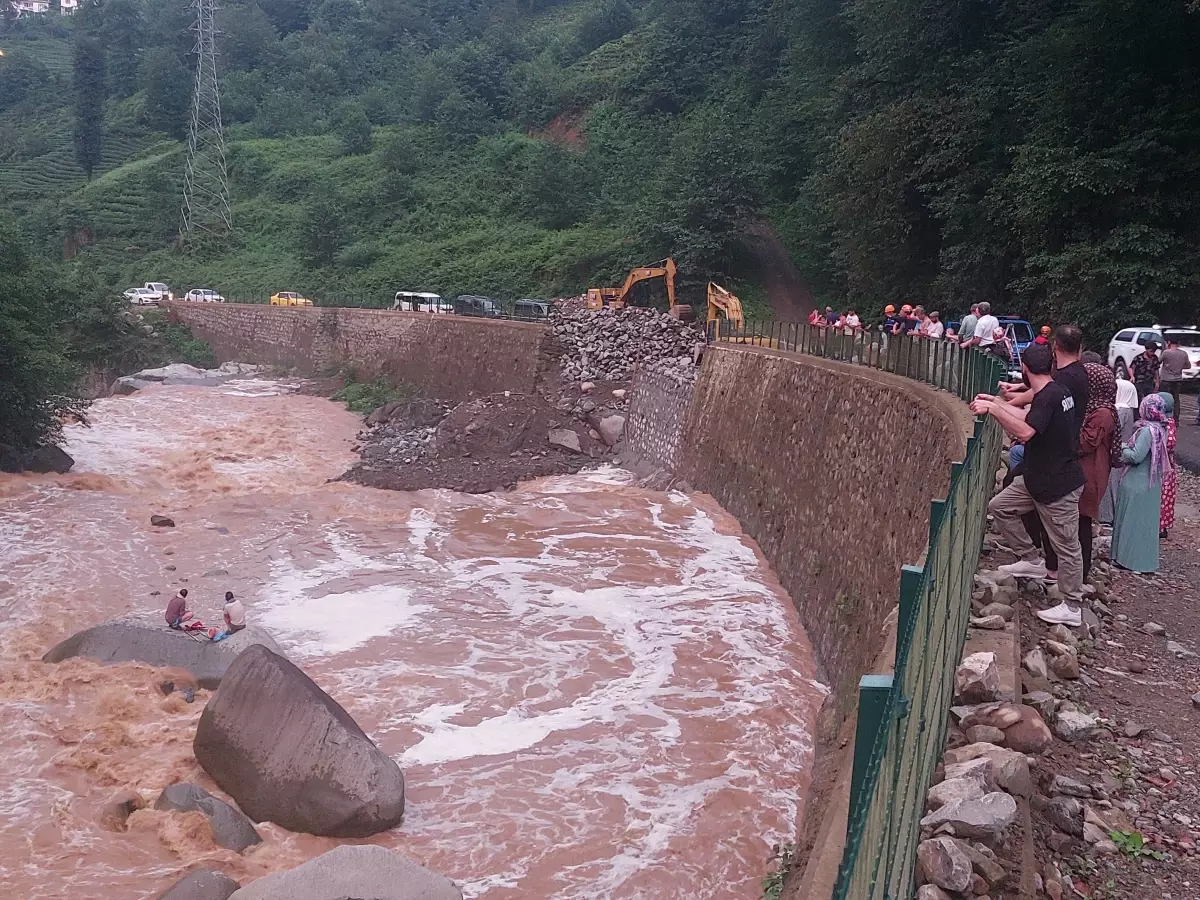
[{"x1": 971, "y1": 344, "x2": 1085, "y2": 626}]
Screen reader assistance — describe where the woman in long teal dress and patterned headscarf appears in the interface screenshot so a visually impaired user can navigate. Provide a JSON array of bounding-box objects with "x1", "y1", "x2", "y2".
[{"x1": 1112, "y1": 394, "x2": 1171, "y2": 572}]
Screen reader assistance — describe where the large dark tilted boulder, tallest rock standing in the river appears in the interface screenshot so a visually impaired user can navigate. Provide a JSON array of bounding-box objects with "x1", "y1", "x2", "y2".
[{"x1": 192, "y1": 646, "x2": 404, "y2": 840}]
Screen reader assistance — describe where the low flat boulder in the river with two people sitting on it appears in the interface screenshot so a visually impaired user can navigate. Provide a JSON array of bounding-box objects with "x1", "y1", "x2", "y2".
[{"x1": 42, "y1": 614, "x2": 280, "y2": 689}]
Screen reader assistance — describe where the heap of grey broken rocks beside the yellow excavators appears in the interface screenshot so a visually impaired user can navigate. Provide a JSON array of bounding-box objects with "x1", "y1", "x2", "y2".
[{"x1": 551, "y1": 301, "x2": 704, "y2": 382}]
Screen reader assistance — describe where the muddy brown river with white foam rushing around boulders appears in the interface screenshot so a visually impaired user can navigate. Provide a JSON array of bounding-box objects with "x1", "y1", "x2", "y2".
[{"x1": 0, "y1": 380, "x2": 824, "y2": 900}]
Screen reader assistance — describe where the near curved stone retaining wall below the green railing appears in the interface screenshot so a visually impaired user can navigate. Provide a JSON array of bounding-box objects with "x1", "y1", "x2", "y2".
[{"x1": 681, "y1": 347, "x2": 972, "y2": 720}]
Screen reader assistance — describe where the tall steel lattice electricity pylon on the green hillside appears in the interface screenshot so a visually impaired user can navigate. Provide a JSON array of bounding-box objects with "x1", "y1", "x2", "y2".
[{"x1": 179, "y1": 0, "x2": 233, "y2": 242}]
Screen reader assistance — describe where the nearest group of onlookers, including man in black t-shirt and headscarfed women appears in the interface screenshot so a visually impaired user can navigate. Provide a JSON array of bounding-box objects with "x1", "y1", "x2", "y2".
[{"x1": 971, "y1": 321, "x2": 1190, "y2": 625}]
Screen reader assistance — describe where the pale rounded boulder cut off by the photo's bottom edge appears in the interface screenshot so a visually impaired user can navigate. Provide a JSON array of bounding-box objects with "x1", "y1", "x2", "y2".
[{"x1": 230, "y1": 844, "x2": 462, "y2": 900}]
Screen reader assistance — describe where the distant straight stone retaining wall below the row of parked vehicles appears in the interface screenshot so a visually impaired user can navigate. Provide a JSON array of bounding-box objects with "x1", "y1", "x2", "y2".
[{"x1": 168, "y1": 302, "x2": 553, "y2": 400}]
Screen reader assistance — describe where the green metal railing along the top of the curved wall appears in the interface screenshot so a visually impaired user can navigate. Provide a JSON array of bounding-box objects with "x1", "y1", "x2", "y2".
[{"x1": 709, "y1": 320, "x2": 1007, "y2": 900}]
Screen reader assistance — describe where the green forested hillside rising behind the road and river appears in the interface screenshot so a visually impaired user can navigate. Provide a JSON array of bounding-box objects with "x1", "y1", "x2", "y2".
[{"x1": 0, "y1": 0, "x2": 1200, "y2": 341}]
